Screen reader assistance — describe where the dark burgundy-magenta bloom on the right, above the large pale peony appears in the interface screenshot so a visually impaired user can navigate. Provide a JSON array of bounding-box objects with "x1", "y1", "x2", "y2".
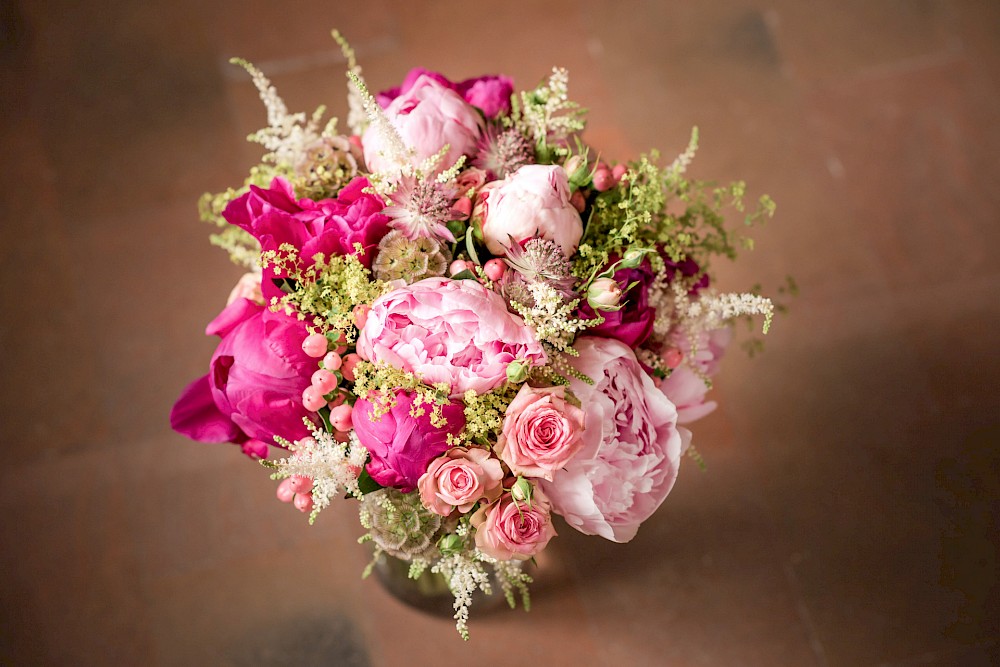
[{"x1": 579, "y1": 259, "x2": 656, "y2": 349}]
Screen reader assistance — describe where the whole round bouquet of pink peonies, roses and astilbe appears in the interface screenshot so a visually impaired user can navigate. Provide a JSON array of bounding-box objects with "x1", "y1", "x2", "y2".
[{"x1": 171, "y1": 32, "x2": 774, "y2": 638}]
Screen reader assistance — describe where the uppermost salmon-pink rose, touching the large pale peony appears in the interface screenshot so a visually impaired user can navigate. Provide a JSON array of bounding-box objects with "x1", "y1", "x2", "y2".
[{"x1": 494, "y1": 384, "x2": 584, "y2": 481}]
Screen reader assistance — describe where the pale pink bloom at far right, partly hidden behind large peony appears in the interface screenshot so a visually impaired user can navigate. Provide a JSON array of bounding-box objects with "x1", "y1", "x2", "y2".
[{"x1": 660, "y1": 327, "x2": 733, "y2": 424}]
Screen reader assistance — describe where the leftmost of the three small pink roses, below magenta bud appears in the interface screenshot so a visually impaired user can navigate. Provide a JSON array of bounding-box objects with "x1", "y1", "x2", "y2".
[{"x1": 417, "y1": 447, "x2": 503, "y2": 516}]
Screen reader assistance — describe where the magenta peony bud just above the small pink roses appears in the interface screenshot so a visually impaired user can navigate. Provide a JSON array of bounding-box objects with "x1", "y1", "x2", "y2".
[{"x1": 351, "y1": 391, "x2": 465, "y2": 493}]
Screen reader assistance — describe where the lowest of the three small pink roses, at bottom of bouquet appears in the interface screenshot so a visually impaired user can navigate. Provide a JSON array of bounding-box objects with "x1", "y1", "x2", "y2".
[{"x1": 471, "y1": 488, "x2": 556, "y2": 560}]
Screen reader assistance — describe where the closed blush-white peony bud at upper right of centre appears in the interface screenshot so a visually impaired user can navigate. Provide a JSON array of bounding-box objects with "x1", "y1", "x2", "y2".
[{"x1": 482, "y1": 164, "x2": 583, "y2": 257}]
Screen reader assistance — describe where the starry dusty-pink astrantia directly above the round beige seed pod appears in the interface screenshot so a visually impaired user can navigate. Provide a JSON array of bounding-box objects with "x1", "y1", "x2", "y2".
[{"x1": 382, "y1": 176, "x2": 458, "y2": 243}]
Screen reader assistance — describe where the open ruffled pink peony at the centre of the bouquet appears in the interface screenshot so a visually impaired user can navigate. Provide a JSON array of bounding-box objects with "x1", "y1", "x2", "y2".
[{"x1": 358, "y1": 278, "x2": 546, "y2": 398}]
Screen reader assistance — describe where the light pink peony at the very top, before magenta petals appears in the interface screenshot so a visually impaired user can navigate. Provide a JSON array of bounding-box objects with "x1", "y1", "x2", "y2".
[{"x1": 361, "y1": 74, "x2": 485, "y2": 176}]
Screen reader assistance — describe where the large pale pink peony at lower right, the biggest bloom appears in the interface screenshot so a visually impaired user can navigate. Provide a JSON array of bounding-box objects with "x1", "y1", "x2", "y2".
[{"x1": 541, "y1": 336, "x2": 690, "y2": 542}]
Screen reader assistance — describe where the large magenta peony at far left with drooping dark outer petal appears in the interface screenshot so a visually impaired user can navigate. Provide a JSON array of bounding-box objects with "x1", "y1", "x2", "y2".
[{"x1": 170, "y1": 298, "x2": 316, "y2": 452}]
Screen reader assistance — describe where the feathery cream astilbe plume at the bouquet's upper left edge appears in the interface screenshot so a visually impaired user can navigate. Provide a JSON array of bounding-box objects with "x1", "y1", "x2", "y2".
[{"x1": 229, "y1": 58, "x2": 337, "y2": 167}]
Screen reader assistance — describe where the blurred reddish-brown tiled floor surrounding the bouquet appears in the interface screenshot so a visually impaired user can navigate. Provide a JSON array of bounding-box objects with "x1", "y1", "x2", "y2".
[{"x1": 0, "y1": 0, "x2": 1000, "y2": 667}]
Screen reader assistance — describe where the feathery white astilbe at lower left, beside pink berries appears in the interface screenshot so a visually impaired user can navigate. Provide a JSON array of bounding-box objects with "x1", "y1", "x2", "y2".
[{"x1": 268, "y1": 429, "x2": 368, "y2": 523}]
